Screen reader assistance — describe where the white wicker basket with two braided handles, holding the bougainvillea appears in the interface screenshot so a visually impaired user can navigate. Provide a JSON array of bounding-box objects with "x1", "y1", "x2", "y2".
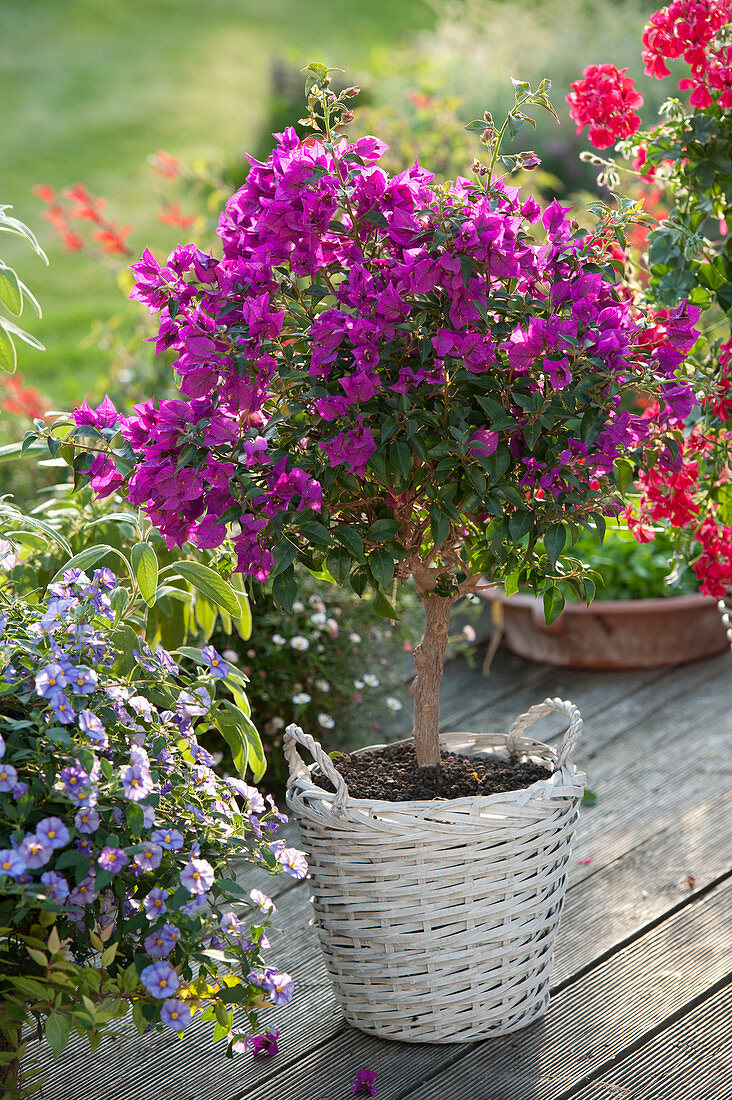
[{"x1": 285, "y1": 699, "x2": 584, "y2": 1043}]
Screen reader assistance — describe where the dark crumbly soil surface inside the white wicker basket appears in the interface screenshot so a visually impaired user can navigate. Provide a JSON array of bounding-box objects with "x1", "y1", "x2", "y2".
[{"x1": 313, "y1": 745, "x2": 549, "y2": 802}]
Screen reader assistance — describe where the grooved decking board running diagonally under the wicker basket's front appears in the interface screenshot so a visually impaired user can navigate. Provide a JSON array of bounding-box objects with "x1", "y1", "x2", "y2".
[{"x1": 236, "y1": 881, "x2": 732, "y2": 1100}]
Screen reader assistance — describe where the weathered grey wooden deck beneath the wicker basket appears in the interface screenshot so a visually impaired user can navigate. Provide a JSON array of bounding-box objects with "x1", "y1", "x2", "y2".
[{"x1": 25, "y1": 651, "x2": 732, "y2": 1100}]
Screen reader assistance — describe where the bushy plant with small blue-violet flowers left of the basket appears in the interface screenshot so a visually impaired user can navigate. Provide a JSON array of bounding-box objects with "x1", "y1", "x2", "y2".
[{"x1": 0, "y1": 569, "x2": 306, "y2": 1095}]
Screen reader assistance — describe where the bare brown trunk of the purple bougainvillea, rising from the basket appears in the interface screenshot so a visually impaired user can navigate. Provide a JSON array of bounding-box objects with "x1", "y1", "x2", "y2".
[{"x1": 412, "y1": 595, "x2": 455, "y2": 768}]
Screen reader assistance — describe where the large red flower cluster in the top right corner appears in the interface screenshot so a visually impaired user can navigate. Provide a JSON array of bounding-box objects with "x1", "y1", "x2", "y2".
[{"x1": 643, "y1": 0, "x2": 732, "y2": 110}]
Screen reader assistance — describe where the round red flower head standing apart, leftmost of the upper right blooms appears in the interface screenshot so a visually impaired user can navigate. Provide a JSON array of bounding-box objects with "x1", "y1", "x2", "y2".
[{"x1": 567, "y1": 62, "x2": 643, "y2": 149}]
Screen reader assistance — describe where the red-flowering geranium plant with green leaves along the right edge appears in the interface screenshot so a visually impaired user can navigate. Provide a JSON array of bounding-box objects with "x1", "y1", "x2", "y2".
[{"x1": 561, "y1": 0, "x2": 732, "y2": 598}]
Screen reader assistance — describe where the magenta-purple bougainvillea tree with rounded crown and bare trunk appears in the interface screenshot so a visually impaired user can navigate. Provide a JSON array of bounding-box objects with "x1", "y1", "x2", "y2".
[{"x1": 34, "y1": 66, "x2": 696, "y2": 767}]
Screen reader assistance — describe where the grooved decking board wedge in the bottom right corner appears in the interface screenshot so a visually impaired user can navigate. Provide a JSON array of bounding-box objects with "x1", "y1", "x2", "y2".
[{"x1": 560, "y1": 986, "x2": 732, "y2": 1100}]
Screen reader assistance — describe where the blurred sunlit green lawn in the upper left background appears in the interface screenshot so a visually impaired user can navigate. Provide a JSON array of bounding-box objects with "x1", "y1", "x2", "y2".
[{"x1": 0, "y1": 0, "x2": 433, "y2": 406}]
